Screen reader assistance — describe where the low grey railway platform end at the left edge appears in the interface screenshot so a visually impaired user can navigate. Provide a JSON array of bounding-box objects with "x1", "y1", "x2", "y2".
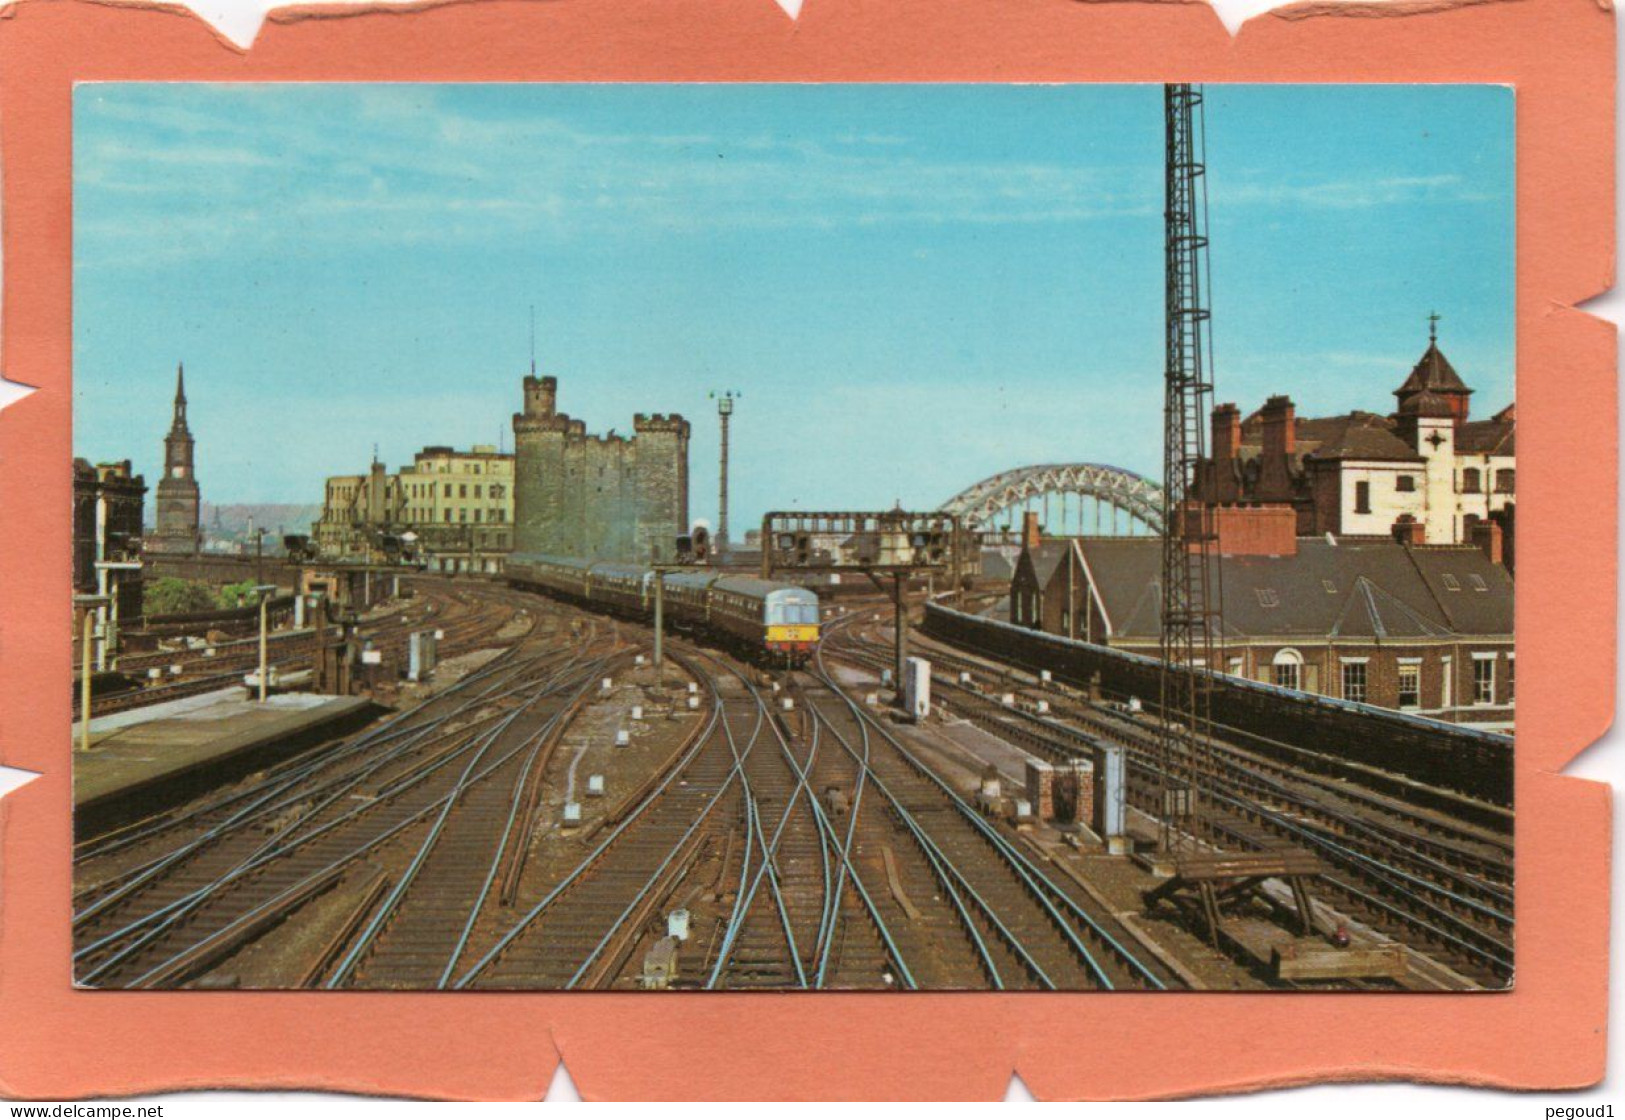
[{"x1": 73, "y1": 688, "x2": 379, "y2": 840}]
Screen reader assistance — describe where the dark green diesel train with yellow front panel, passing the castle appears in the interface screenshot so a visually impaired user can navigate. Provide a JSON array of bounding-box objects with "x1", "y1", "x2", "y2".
[{"x1": 507, "y1": 554, "x2": 819, "y2": 666}]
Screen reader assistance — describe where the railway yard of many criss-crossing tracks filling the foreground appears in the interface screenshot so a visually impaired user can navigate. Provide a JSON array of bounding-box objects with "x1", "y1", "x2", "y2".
[{"x1": 63, "y1": 577, "x2": 1513, "y2": 990}]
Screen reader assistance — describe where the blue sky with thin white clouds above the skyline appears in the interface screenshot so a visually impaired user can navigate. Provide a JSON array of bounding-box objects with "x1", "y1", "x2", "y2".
[{"x1": 73, "y1": 83, "x2": 1515, "y2": 535}]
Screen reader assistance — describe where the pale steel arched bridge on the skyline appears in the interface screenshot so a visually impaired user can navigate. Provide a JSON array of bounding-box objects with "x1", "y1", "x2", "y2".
[{"x1": 943, "y1": 463, "x2": 1162, "y2": 535}]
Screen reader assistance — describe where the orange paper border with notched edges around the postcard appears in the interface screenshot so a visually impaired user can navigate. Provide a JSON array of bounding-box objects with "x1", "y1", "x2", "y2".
[{"x1": 0, "y1": 0, "x2": 1617, "y2": 1099}]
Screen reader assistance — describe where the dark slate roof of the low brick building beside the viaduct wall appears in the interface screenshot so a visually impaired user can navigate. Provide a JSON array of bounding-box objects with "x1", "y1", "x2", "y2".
[{"x1": 1079, "y1": 538, "x2": 1513, "y2": 642}]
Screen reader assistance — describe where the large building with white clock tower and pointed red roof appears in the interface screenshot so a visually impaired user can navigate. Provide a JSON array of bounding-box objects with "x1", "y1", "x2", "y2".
[{"x1": 1198, "y1": 330, "x2": 1518, "y2": 555}]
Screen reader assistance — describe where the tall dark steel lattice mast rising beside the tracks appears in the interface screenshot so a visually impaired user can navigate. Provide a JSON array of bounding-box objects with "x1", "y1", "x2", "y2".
[{"x1": 1159, "y1": 85, "x2": 1219, "y2": 849}]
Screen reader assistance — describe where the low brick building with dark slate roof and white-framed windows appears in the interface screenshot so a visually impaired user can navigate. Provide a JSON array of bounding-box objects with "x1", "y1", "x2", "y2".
[{"x1": 1009, "y1": 507, "x2": 1516, "y2": 730}]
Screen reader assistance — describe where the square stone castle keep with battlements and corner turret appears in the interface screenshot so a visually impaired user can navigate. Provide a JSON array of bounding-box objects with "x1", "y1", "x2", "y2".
[{"x1": 514, "y1": 377, "x2": 689, "y2": 561}]
